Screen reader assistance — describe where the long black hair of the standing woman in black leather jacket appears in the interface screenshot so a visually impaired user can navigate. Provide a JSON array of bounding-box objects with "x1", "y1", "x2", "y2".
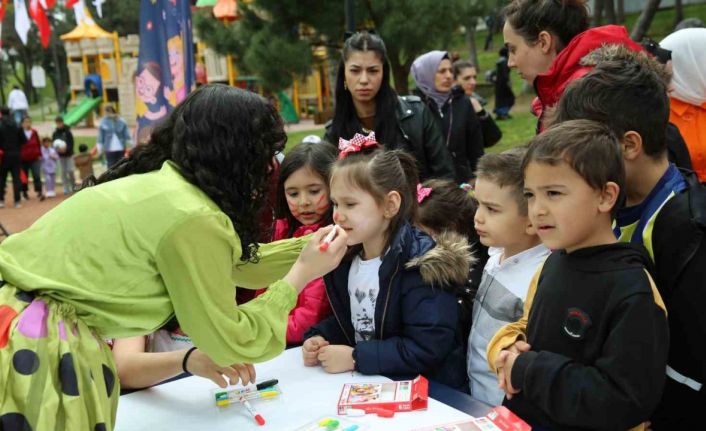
[{"x1": 330, "y1": 31, "x2": 399, "y2": 145}]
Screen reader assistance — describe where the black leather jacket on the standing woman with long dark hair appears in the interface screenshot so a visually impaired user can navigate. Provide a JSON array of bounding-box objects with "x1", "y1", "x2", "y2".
[{"x1": 324, "y1": 96, "x2": 455, "y2": 181}]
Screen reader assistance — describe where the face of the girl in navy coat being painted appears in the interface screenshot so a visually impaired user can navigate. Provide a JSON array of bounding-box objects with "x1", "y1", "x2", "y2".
[{"x1": 331, "y1": 173, "x2": 394, "y2": 258}]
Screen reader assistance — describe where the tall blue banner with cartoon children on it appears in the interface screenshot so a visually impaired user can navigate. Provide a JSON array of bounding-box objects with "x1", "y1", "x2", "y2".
[{"x1": 135, "y1": 0, "x2": 195, "y2": 143}]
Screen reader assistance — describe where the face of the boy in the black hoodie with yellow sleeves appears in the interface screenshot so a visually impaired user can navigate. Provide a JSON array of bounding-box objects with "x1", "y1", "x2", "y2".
[{"x1": 524, "y1": 162, "x2": 618, "y2": 252}]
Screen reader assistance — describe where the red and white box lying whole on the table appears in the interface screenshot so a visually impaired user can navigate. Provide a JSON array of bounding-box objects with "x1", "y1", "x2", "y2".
[{"x1": 338, "y1": 376, "x2": 429, "y2": 415}]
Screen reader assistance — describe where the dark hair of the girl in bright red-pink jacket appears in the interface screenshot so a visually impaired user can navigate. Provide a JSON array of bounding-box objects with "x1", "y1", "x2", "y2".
[{"x1": 275, "y1": 142, "x2": 338, "y2": 238}]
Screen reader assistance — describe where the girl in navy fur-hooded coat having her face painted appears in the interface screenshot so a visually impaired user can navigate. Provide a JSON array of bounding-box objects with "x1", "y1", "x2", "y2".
[{"x1": 302, "y1": 133, "x2": 470, "y2": 388}]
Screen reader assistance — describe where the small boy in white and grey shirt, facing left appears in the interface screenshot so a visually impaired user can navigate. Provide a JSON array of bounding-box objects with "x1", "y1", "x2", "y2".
[{"x1": 468, "y1": 148, "x2": 549, "y2": 406}]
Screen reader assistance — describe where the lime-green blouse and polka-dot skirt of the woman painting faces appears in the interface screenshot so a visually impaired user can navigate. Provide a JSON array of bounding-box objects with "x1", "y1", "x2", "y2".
[{"x1": 0, "y1": 162, "x2": 308, "y2": 430}]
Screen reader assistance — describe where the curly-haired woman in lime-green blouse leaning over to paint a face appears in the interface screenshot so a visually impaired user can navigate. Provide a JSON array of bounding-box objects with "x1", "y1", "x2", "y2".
[{"x1": 0, "y1": 85, "x2": 346, "y2": 430}]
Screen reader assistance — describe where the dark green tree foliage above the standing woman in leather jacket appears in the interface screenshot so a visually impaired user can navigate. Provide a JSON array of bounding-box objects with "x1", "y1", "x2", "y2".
[{"x1": 194, "y1": 0, "x2": 468, "y2": 94}]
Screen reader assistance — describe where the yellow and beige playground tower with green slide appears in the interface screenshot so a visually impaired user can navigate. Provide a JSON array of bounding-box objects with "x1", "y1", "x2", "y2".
[{"x1": 61, "y1": 7, "x2": 140, "y2": 127}]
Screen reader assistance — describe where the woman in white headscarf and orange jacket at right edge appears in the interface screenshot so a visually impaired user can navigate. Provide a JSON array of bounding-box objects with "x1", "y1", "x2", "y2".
[{"x1": 660, "y1": 28, "x2": 706, "y2": 182}]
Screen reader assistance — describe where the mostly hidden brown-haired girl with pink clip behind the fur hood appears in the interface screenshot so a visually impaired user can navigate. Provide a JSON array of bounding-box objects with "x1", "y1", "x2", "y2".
[{"x1": 415, "y1": 180, "x2": 488, "y2": 351}]
